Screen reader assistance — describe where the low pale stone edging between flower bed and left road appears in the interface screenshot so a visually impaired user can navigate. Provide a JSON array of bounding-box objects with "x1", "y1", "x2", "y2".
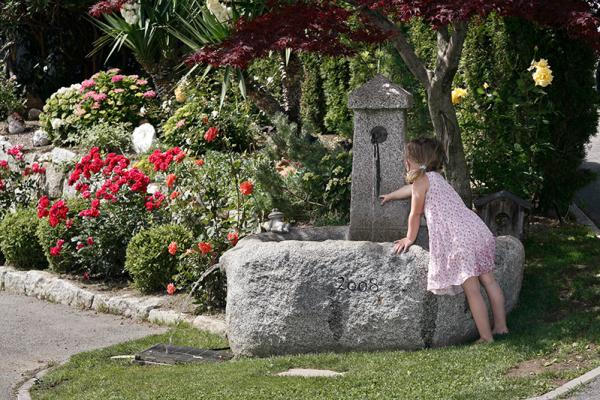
[{"x1": 0, "y1": 266, "x2": 227, "y2": 337}]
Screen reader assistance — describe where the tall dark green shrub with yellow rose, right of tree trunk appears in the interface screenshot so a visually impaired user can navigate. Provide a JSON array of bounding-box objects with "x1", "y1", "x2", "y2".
[{"x1": 455, "y1": 16, "x2": 598, "y2": 213}]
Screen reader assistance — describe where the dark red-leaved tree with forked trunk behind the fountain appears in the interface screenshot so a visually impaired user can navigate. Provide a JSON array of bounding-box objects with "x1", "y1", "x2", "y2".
[{"x1": 188, "y1": 0, "x2": 600, "y2": 204}]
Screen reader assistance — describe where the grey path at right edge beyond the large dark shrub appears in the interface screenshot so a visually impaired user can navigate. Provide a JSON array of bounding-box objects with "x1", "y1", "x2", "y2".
[{"x1": 575, "y1": 133, "x2": 600, "y2": 226}]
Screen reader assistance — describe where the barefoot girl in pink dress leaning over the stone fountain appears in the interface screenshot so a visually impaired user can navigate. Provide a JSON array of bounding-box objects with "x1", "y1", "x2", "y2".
[{"x1": 380, "y1": 138, "x2": 508, "y2": 342}]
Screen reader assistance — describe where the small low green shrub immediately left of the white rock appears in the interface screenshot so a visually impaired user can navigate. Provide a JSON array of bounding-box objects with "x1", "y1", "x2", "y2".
[{"x1": 79, "y1": 121, "x2": 133, "y2": 153}]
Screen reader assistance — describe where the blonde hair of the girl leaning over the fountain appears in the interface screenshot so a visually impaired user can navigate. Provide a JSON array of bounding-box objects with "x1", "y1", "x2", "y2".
[{"x1": 404, "y1": 137, "x2": 445, "y2": 184}]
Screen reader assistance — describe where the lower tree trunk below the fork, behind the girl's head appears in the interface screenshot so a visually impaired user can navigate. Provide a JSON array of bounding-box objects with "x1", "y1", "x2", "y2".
[{"x1": 427, "y1": 86, "x2": 472, "y2": 207}]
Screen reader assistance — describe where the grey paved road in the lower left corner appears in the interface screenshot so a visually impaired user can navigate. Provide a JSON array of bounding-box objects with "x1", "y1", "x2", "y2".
[{"x1": 0, "y1": 292, "x2": 165, "y2": 400}]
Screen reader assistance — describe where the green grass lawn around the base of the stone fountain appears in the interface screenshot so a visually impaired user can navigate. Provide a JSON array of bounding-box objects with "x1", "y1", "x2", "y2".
[{"x1": 32, "y1": 225, "x2": 600, "y2": 400}]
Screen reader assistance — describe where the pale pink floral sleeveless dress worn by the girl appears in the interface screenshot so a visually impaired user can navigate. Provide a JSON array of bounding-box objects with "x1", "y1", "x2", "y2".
[{"x1": 425, "y1": 171, "x2": 496, "y2": 295}]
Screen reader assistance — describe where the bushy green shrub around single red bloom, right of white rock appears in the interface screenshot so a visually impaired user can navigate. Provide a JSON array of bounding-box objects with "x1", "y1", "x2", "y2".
[{"x1": 163, "y1": 74, "x2": 258, "y2": 155}]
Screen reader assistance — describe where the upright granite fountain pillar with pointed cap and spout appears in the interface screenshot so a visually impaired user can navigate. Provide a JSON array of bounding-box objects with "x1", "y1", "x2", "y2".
[{"x1": 348, "y1": 75, "x2": 412, "y2": 244}]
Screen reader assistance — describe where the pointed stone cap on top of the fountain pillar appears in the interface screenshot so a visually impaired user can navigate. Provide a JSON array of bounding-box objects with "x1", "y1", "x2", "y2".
[{"x1": 348, "y1": 74, "x2": 413, "y2": 110}]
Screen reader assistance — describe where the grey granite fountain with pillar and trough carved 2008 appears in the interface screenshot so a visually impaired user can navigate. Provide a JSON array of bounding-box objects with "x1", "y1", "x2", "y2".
[{"x1": 220, "y1": 75, "x2": 524, "y2": 356}]
